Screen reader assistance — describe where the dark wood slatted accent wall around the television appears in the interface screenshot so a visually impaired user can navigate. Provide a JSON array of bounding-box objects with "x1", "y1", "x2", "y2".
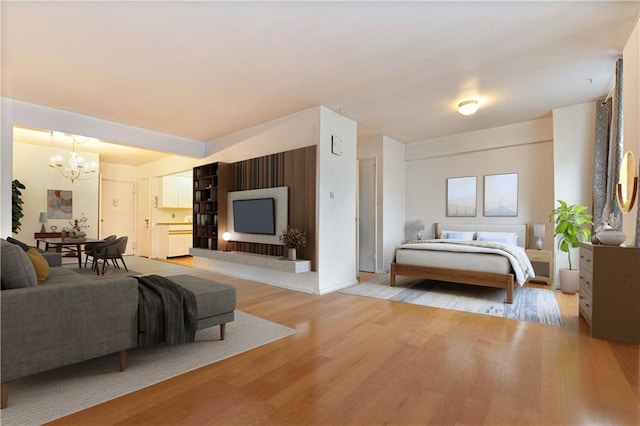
[{"x1": 229, "y1": 146, "x2": 317, "y2": 271}]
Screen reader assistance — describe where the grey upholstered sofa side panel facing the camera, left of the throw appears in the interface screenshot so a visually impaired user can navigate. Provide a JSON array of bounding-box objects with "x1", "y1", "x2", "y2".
[{"x1": 0, "y1": 277, "x2": 138, "y2": 383}]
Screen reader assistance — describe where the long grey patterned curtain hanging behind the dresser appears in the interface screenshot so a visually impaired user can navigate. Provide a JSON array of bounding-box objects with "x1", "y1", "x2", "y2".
[{"x1": 593, "y1": 58, "x2": 623, "y2": 230}]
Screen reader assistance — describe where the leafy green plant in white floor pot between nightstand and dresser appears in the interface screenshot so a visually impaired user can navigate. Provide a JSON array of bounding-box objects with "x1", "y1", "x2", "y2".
[{"x1": 549, "y1": 200, "x2": 593, "y2": 294}]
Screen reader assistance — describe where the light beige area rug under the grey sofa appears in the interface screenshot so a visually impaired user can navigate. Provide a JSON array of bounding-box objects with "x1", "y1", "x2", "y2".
[{"x1": 0, "y1": 311, "x2": 296, "y2": 425}]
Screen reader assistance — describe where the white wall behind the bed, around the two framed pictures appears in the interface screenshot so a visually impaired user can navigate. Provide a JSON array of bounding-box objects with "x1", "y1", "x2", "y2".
[{"x1": 405, "y1": 119, "x2": 554, "y2": 249}]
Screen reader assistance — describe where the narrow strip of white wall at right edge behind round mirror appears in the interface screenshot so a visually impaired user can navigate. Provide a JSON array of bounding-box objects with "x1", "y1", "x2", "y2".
[{"x1": 622, "y1": 20, "x2": 640, "y2": 245}]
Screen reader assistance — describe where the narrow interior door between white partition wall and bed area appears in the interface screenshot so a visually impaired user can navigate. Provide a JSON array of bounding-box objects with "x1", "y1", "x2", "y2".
[{"x1": 358, "y1": 158, "x2": 376, "y2": 272}]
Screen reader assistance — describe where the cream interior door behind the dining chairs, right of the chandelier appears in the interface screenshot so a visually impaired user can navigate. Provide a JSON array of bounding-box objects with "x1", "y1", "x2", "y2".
[{"x1": 100, "y1": 179, "x2": 136, "y2": 254}]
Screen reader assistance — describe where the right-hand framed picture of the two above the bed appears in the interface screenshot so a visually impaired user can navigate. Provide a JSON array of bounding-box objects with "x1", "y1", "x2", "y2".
[{"x1": 484, "y1": 173, "x2": 518, "y2": 217}]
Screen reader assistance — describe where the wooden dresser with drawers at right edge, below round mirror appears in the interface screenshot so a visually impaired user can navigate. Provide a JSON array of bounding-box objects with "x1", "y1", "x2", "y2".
[{"x1": 579, "y1": 243, "x2": 640, "y2": 344}]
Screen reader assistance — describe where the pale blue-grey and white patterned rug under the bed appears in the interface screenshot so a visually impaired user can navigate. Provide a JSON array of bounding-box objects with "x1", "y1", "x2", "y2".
[{"x1": 341, "y1": 275, "x2": 564, "y2": 327}]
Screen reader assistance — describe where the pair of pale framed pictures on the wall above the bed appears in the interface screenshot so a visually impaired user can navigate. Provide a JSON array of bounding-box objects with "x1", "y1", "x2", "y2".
[{"x1": 447, "y1": 173, "x2": 518, "y2": 217}]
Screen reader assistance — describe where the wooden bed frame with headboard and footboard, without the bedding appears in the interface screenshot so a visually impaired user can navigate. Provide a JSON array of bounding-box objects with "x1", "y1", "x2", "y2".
[{"x1": 391, "y1": 223, "x2": 529, "y2": 303}]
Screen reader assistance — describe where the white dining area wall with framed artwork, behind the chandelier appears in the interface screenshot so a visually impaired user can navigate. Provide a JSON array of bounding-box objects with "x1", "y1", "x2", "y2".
[{"x1": 13, "y1": 143, "x2": 99, "y2": 245}]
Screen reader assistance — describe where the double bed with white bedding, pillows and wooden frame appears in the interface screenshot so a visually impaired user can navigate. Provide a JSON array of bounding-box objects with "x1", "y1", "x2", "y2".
[{"x1": 390, "y1": 223, "x2": 535, "y2": 303}]
